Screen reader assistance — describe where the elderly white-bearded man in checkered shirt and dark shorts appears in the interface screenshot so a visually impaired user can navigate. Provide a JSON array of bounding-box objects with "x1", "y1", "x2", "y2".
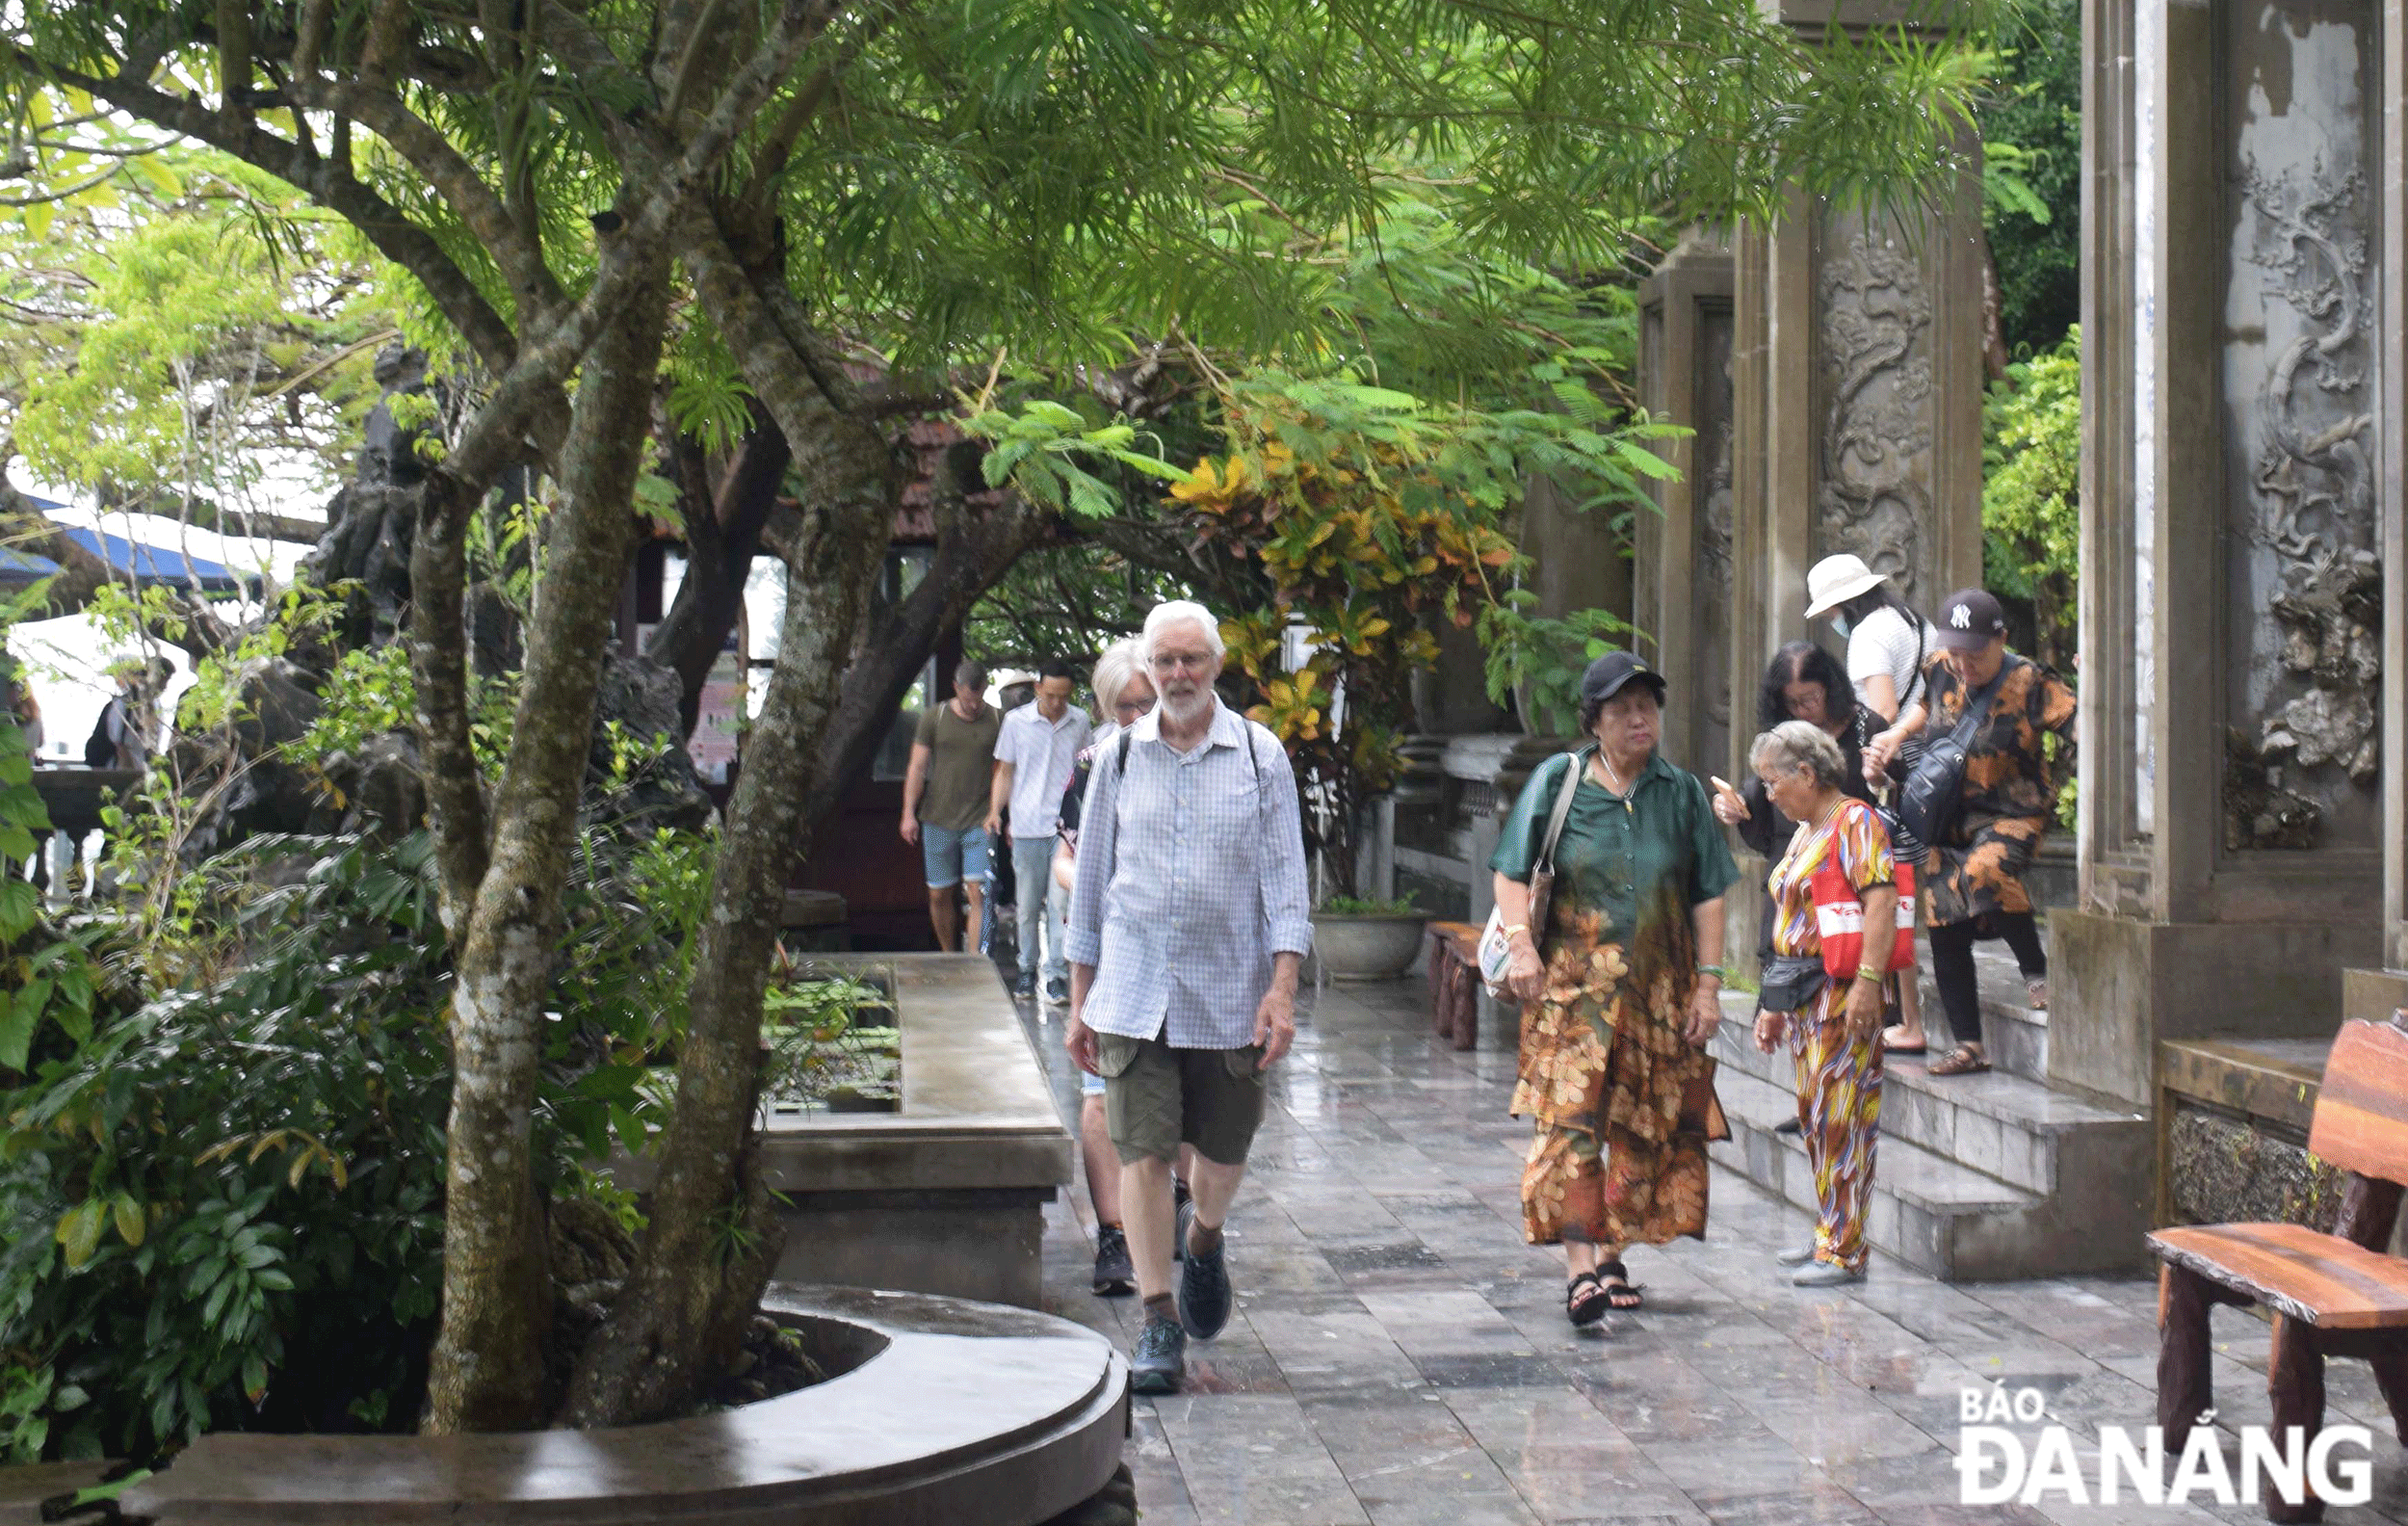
[{"x1": 1067, "y1": 599, "x2": 1313, "y2": 1394}]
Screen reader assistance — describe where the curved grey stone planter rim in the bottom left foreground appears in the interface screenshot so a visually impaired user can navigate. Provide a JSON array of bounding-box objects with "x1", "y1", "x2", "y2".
[{"x1": 120, "y1": 1283, "x2": 1130, "y2": 1526}]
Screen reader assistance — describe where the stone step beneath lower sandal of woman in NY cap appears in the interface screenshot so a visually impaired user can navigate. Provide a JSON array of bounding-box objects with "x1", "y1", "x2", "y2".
[{"x1": 1713, "y1": 994, "x2": 2146, "y2": 1194}]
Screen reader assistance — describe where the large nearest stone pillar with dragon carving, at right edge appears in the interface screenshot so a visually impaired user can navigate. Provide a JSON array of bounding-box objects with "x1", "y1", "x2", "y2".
[{"x1": 2050, "y1": 0, "x2": 2401, "y2": 1102}]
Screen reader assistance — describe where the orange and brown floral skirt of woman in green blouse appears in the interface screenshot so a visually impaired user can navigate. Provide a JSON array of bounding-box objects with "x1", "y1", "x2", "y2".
[{"x1": 1512, "y1": 919, "x2": 1713, "y2": 1247}]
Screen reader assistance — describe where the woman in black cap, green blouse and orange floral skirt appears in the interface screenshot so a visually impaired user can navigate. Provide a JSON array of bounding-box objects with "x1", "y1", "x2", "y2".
[{"x1": 1488, "y1": 652, "x2": 1739, "y2": 1327}]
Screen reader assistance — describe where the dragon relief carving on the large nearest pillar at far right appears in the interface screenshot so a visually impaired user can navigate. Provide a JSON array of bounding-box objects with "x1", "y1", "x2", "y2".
[{"x1": 2225, "y1": 159, "x2": 2384, "y2": 847}]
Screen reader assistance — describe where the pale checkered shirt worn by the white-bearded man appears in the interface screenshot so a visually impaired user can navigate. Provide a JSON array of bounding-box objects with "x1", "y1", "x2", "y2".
[{"x1": 1069, "y1": 700, "x2": 1313, "y2": 1049}]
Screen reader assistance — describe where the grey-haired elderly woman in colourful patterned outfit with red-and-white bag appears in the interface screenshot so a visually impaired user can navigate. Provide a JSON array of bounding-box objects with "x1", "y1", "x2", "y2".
[{"x1": 1748, "y1": 720, "x2": 1898, "y2": 1288}]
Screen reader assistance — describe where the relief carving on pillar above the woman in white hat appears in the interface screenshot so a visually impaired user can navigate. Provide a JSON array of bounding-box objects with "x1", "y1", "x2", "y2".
[{"x1": 1816, "y1": 231, "x2": 1931, "y2": 599}]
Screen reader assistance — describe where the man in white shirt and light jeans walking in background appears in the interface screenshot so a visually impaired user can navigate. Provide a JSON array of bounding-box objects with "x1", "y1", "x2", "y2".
[{"x1": 987, "y1": 660, "x2": 1093, "y2": 1006}]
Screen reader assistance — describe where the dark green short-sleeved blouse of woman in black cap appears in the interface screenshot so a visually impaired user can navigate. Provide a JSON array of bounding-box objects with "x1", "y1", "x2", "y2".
[{"x1": 1488, "y1": 753, "x2": 1739, "y2": 941}]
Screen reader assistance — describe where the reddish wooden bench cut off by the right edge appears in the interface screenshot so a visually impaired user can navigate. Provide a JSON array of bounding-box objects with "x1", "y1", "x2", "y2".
[{"x1": 2148, "y1": 1011, "x2": 2408, "y2": 1521}]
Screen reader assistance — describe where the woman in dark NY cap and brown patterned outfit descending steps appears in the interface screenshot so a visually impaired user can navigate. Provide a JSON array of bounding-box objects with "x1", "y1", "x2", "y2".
[{"x1": 1864, "y1": 588, "x2": 2074, "y2": 1076}]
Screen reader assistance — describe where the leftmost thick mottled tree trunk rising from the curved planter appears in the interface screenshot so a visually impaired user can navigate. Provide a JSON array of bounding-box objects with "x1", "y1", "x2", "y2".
[{"x1": 419, "y1": 260, "x2": 667, "y2": 1434}]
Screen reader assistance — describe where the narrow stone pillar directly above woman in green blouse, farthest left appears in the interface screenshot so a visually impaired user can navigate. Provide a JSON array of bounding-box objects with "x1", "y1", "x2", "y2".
[{"x1": 1633, "y1": 233, "x2": 1756, "y2": 777}]
